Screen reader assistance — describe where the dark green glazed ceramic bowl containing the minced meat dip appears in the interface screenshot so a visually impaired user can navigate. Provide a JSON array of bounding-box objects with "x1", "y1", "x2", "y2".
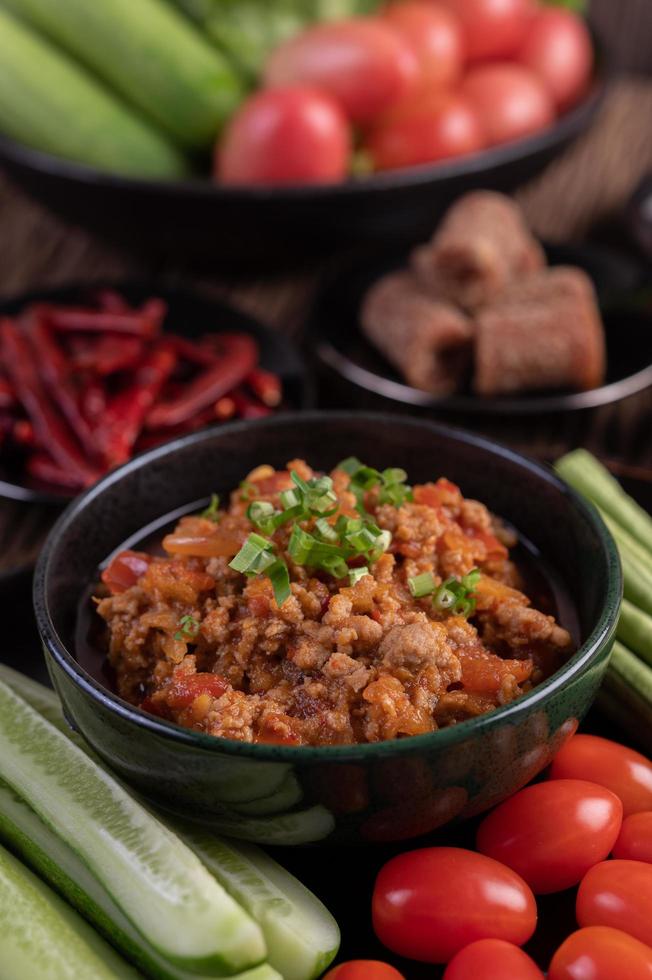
[{"x1": 34, "y1": 412, "x2": 621, "y2": 844}]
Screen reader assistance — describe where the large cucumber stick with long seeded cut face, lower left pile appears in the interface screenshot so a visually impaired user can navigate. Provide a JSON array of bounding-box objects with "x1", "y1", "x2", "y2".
[{"x1": 0, "y1": 681, "x2": 266, "y2": 976}]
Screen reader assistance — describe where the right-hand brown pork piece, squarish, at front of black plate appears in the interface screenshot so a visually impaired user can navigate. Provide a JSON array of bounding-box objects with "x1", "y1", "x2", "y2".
[{"x1": 473, "y1": 266, "x2": 605, "y2": 395}]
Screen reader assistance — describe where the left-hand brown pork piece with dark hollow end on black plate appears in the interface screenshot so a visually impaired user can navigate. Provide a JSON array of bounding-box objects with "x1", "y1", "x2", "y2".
[{"x1": 360, "y1": 271, "x2": 473, "y2": 395}]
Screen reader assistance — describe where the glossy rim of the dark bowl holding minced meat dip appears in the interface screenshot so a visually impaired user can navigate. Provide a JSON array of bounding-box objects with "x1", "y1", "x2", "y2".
[{"x1": 33, "y1": 410, "x2": 623, "y2": 765}]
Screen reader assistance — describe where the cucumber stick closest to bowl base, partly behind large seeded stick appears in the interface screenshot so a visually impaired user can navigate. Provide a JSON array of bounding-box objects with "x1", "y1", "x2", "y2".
[{"x1": 177, "y1": 825, "x2": 340, "y2": 980}]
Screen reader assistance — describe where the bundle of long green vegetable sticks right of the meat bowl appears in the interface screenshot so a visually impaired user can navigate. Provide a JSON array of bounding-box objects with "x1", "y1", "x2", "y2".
[{"x1": 555, "y1": 449, "x2": 652, "y2": 751}]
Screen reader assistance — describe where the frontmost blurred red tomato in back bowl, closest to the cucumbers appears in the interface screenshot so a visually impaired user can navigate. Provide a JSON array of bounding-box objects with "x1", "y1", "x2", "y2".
[{"x1": 216, "y1": 86, "x2": 351, "y2": 184}]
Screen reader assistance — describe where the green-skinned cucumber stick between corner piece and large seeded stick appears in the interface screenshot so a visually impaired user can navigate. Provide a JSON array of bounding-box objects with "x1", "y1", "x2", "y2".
[{"x1": 0, "y1": 781, "x2": 281, "y2": 980}]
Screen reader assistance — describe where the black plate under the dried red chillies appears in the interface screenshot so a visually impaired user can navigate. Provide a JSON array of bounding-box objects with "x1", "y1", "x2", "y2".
[{"x1": 0, "y1": 282, "x2": 312, "y2": 506}]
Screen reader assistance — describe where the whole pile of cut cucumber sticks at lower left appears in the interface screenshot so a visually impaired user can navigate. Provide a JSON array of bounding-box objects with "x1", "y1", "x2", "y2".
[{"x1": 0, "y1": 666, "x2": 339, "y2": 980}]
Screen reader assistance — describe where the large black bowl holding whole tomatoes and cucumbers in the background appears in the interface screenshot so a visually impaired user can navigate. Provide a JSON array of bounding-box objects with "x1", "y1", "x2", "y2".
[{"x1": 0, "y1": 77, "x2": 606, "y2": 273}]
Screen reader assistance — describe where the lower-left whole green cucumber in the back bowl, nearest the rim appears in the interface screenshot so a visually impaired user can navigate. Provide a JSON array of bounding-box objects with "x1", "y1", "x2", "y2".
[{"x1": 0, "y1": 4, "x2": 188, "y2": 178}]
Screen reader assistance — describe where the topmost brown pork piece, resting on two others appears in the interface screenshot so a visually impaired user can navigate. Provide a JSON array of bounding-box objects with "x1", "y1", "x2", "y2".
[{"x1": 411, "y1": 191, "x2": 545, "y2": 311}]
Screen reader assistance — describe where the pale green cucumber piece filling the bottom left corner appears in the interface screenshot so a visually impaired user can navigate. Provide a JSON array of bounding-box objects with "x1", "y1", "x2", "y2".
[{"x1": 0, "y1": 847, "x2": 137, "y2": 980}]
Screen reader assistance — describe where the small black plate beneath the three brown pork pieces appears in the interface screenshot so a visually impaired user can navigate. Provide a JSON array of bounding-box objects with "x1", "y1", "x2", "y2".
[{"x1": 311, "y1": 245, "x2": 652, "y2": 416}]
